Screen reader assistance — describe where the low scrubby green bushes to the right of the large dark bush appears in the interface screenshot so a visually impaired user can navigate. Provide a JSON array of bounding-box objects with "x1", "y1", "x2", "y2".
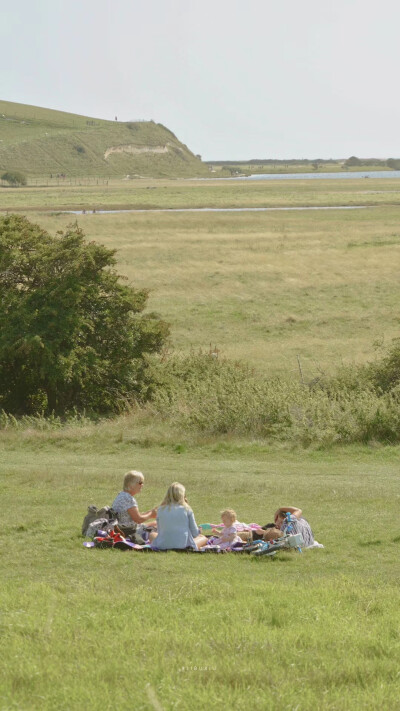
[{"x1": 145, "y1": 354, "x2": 400, "y2": 446}]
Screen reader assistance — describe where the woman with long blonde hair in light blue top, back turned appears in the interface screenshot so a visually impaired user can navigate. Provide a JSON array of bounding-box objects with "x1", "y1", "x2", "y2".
[{"x1": 151, "y1": 481, "x2": 207, "y2": 550}]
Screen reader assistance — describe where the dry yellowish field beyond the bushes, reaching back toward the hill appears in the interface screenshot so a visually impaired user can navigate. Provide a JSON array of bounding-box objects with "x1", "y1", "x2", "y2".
[{"x1": 0, "y1": 180, "x2": 400, "y2": 379}]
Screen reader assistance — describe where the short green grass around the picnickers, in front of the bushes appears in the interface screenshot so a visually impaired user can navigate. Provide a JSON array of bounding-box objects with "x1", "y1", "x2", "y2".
[{"x1": 0, "y1": 418, "x2": 400, "y2": 711}]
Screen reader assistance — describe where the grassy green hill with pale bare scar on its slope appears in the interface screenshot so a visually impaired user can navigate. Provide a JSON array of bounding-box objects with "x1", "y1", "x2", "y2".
[{"x1": 0, "y1": 101, "x2": 209, "y2": 178}]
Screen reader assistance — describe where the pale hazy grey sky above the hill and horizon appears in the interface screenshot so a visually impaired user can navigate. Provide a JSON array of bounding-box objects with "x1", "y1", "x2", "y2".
[{"x1": 0, "y1": 0, "x2": 400, "y2": 160}]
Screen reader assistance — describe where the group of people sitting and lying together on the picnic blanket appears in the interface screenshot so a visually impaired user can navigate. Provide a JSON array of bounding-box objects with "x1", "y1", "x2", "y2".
[{"x1": 112, "y1": 471, "x2": 315, "y2": 550}]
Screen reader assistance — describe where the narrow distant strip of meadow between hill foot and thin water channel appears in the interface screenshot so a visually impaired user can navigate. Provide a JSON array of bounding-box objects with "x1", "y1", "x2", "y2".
[{"x1": 0, "y1": 173, "x2": 400, "y2": 211}]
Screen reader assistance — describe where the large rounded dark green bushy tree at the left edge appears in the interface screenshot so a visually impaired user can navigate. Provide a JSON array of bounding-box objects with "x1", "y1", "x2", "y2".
[{"x1": 0, "y1": 215, "x2": 168, "y2": 413}]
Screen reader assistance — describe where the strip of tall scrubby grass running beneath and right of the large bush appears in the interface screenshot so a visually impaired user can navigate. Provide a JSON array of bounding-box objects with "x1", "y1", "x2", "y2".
[{"x1": 0, "y1": 354, "x2": 400, "y2": 447}]
